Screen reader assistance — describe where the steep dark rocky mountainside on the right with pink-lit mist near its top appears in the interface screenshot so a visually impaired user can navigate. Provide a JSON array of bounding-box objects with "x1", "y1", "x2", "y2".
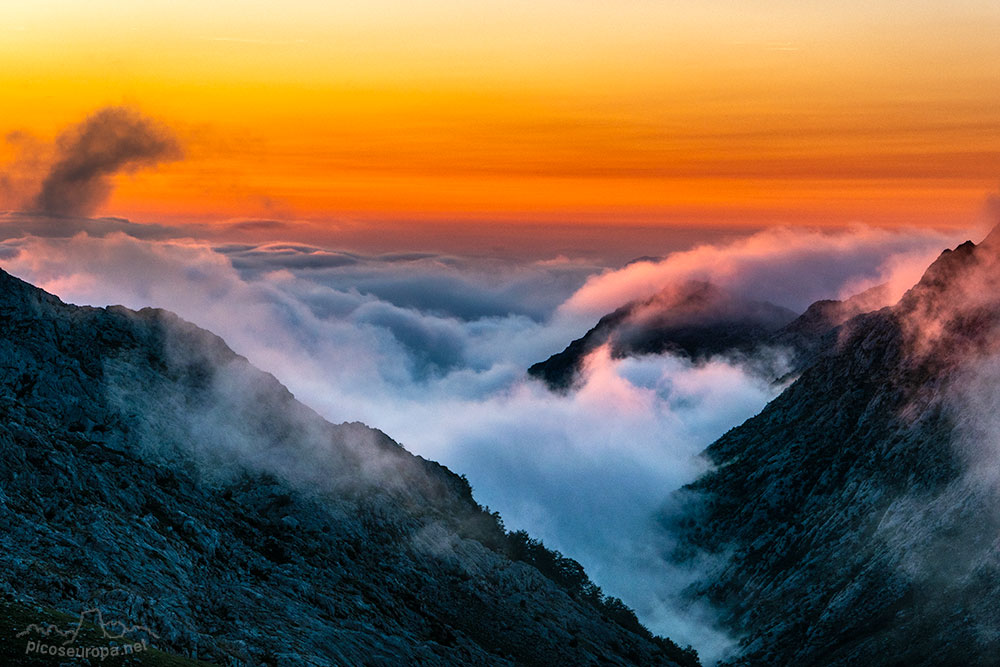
[{"x1": 662, "y1": 233, "x2": 1000, "y2": 666}]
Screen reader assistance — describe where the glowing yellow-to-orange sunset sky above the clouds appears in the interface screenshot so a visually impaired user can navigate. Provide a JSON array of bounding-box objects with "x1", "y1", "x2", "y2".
[{"x1": 0, "y1": 0, "x2": 1000, "y2": 237}]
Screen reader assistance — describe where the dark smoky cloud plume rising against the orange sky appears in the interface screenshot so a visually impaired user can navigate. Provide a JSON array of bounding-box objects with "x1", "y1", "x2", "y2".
[{"x1": 34, "y1": 107, "x2": 181, "y2": 215}]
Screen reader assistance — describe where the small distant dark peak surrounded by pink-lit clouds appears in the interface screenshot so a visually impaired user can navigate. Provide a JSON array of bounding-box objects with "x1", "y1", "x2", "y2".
[{"x1": 528, "y1": 281, "x2": 795, "y2": 390}]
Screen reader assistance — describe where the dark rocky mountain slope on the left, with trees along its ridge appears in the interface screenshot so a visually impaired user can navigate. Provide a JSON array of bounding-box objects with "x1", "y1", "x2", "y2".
[{"x1": 0, "y1": 272, "x2": 697, "y2": 665}]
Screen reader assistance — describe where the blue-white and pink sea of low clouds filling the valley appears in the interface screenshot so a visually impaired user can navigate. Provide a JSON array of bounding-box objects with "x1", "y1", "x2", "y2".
[{"x1": 0, "y1": 223, "x2": 968, "y2": 657}]
